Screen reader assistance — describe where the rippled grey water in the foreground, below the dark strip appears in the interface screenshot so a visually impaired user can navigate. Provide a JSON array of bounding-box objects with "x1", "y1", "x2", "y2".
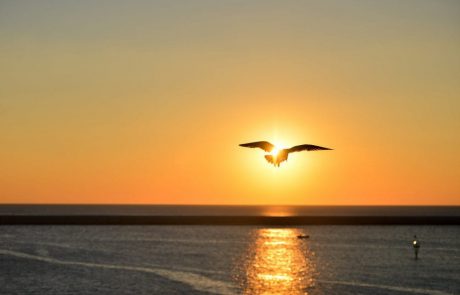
[{"x1": 0, "y1": 226, "x2": 460, "y2": 295}]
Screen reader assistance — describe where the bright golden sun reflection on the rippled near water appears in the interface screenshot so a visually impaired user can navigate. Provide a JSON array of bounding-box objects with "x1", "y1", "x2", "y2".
[{"x1": 237, "y1": 228, "x2": 314, "y2": 294}]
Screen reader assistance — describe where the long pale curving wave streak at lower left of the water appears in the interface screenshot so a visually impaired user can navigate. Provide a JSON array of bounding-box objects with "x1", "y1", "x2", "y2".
[{"x1": 0, "y1": 249, "x2": 236, "y2": 294}]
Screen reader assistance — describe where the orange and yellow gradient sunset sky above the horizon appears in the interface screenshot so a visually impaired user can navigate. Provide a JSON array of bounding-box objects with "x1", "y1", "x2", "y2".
[{"x1": 0, "y1": 0, "x2": 460, "y2": 205}]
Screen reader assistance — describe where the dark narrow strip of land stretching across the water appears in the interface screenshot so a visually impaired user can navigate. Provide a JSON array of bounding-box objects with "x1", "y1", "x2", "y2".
[{"x1": 0, "y1": 215, "x2": 460, "y2": 226}]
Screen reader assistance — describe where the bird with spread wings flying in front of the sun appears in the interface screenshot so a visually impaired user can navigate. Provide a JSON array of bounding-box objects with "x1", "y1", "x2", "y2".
[{"x1": 240, "y1": 141, "x2": 332, "y2": 167}]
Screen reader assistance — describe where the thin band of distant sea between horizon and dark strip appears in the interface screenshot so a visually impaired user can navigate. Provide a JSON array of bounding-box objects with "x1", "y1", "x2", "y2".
[{"x1": 0, "y1": 205, "x2": 460, "y2": 217}]
